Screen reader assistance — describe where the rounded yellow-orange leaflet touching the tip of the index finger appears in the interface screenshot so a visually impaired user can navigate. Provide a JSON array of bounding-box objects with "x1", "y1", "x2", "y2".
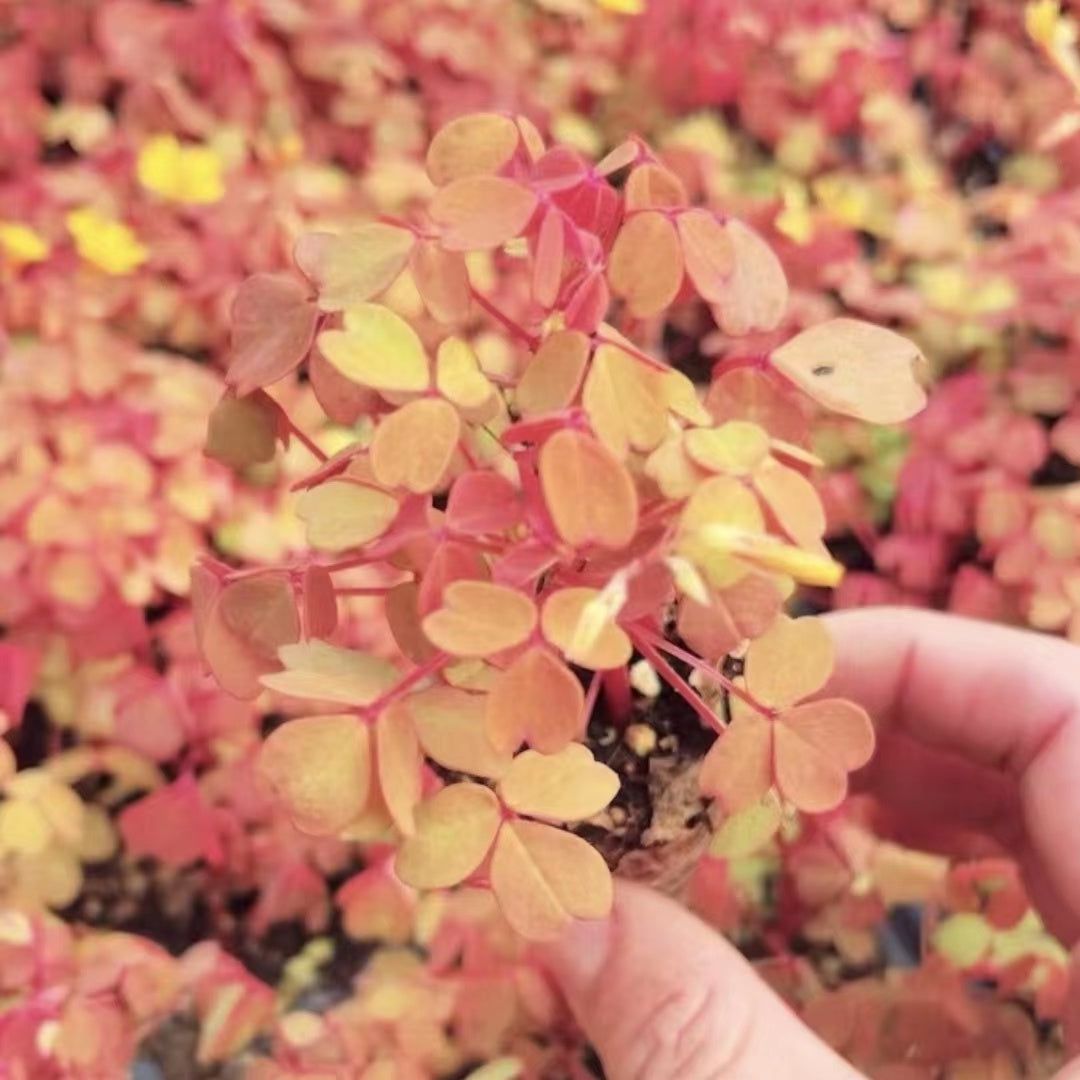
[{"x1": 744, "y1": 615, "x2": 833, "y2": 708}]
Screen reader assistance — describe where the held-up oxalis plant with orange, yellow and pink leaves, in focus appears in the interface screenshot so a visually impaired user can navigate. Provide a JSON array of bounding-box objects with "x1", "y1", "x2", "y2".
[{"x1": 192, "y1": 113, "x2": 924, "y2": 940}]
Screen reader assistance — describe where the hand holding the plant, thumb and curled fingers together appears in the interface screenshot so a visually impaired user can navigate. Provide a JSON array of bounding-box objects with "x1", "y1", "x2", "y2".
[{"x1": 543, "y1": 608, "x2": 1080, "y2": 1080}]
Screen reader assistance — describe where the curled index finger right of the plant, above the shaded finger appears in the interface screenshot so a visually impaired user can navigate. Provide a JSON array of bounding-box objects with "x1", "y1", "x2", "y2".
[{"x1": 825, "y1": 608, "x2": 1080, "y2": 928}]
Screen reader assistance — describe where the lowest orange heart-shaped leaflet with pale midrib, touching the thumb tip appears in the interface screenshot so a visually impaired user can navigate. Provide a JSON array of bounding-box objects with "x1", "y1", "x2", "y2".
[{"x1": 491, "y1": 821, "x2": 612, "y2": 941}]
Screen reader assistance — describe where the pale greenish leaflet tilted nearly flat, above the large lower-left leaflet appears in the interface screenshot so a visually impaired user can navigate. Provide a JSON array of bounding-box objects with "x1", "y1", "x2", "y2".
[{"x1": 262, "y1": 638, "x2": 399, "y2": 705}]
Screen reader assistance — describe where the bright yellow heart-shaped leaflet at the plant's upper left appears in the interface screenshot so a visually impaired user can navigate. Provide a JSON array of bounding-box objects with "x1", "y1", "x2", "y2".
[{"x1": 319, "y1": 303, "x2": 431, "y2": 393}]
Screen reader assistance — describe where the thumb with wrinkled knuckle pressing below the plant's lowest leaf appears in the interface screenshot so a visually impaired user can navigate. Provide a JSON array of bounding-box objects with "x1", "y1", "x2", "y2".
[{"x1": 541, "y1": 882, "x2": 860, "y2": 1080}]
